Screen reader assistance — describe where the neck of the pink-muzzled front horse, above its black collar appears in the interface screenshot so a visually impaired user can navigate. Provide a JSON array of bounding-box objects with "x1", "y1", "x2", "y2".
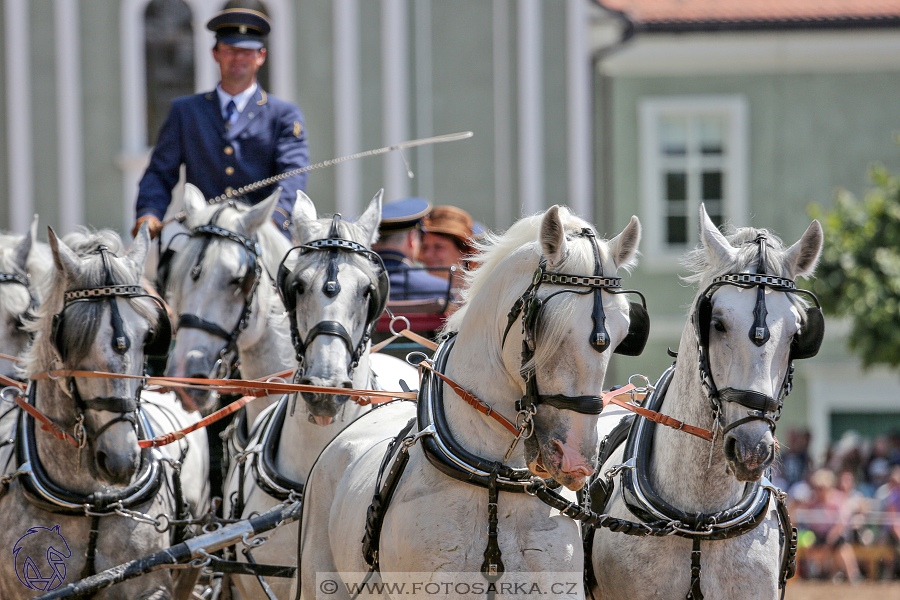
[{"x1": 443, "y1": 327, "x2": 525, "y2": 468}]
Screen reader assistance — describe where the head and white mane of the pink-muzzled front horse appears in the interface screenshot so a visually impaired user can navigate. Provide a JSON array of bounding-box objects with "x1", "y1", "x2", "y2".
[{"x1": 447, "y1": 206, "x2": 648, "y2": 490}]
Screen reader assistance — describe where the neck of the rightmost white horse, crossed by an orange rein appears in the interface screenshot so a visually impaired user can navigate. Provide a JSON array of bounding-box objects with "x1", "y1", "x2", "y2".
[{"x1": 650, "y1": 322, "x2": 744, "y2": 512}]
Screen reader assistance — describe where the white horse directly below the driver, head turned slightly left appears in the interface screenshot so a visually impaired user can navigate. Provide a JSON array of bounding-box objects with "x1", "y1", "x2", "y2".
[{"x1": 159, "y1": 184, "x2": 296, "y2": 423}]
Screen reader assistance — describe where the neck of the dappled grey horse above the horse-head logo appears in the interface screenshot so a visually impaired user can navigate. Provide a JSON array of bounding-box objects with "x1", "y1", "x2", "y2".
[{"x1": 32, "y1": 380, "x2": 102, "y2": 495}]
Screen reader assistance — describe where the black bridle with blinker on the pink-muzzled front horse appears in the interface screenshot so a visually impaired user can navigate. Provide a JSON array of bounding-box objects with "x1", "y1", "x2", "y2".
[{"x1": 503, "y1": 228, "x2": 650, "y2": 415}]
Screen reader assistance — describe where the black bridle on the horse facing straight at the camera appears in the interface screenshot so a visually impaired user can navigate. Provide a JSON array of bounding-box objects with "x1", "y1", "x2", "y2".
[{"x1": 277, "y1": 214, "x2": 391, "y2": 376}]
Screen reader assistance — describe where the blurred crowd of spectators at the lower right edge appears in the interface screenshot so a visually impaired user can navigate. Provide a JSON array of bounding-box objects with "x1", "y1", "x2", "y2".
[{"x1": 773, "y1": 430, "x2": 900, "y2": 582}]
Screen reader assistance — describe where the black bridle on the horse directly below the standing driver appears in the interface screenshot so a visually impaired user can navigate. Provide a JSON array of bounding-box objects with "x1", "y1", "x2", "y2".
[{"x1": 158, "y1": 202, "x2": 262, "y2": 379}]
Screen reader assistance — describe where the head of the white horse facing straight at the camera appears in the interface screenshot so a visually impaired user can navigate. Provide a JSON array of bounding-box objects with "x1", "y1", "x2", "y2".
[{"x1": 278, "y1": 191, "x2": 389, "y2": 425}]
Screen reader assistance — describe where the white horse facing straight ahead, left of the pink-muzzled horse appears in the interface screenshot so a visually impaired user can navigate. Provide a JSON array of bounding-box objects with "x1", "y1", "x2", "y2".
[{"x1": 225, "y1": 192, "x2": 417, "y2": 599}]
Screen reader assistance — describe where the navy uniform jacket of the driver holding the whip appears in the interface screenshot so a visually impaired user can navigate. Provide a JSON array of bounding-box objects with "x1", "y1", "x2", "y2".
[{"x1": 135, "y1": 87, "x2": 309, "y2": 228}]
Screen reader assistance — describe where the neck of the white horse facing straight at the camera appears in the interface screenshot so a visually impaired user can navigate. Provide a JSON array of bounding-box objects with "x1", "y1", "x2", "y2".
[{"x1": 275, "y1": 348, "x2": 372, "y2": 481}]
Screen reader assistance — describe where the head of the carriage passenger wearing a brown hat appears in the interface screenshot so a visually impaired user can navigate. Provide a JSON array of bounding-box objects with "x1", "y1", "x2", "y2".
[{"x1": 419, "y1": 206, "x2": 482, "y2": 288}]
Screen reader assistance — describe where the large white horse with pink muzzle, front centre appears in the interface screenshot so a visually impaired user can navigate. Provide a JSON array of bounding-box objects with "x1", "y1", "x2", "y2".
[{"x1": 299, "y1": 206, "x2": 646, "y2": 599}]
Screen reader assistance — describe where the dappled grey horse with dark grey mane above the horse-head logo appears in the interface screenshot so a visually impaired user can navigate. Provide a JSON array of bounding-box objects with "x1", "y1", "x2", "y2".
[{"x1": 0, "y1": 226, "x2": 208, "y2": 600}]
